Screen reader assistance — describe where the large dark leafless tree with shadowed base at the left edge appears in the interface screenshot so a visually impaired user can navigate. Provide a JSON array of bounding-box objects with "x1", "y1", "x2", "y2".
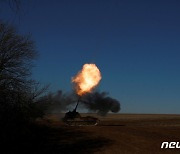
[{"x1": 0, "y1": 22, "x2": 48, "y2": 124}]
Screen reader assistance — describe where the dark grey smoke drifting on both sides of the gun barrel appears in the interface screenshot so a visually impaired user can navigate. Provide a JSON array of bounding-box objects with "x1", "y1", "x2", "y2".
[{"x1": 41, "y1": 90, "x2": 121, "y2": 116}]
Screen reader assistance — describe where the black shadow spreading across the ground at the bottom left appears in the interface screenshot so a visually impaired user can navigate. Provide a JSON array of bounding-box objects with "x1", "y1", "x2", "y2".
[{"x1": 1, "y1": 125, "x2": 112, "y2": 154}]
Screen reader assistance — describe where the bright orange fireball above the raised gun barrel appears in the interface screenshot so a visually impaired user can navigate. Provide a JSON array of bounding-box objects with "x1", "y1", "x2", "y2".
[{"x1": 72, "y1": 64, "x2": 102, "y2": 96}]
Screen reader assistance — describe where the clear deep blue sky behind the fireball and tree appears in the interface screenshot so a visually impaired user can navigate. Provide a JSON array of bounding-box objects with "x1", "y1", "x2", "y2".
[{"x1": 0, "y1": 0, "x2": 180, "y2": 113}]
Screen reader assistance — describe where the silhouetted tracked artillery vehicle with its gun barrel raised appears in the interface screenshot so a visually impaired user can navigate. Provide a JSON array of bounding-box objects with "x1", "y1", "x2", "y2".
[{"x1": 63, "y1": 101, "x2": 100, "y2": 126}]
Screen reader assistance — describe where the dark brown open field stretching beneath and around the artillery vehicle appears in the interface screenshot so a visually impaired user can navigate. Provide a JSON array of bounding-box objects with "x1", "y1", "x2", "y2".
[{"x1": 1, "y1": 114, "x2": 180, "y2": 154}]
